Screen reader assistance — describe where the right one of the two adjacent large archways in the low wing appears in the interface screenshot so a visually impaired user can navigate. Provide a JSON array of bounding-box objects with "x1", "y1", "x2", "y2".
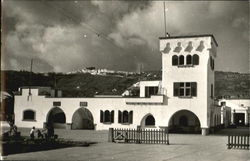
[{"x1": 71, "y1": 108, "x2": 94, "y2": 129}]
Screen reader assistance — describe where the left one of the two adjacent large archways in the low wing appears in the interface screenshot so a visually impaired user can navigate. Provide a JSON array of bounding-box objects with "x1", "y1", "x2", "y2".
[{"x1": 47, "y1": 107, "x2": 66, "y2": 128}]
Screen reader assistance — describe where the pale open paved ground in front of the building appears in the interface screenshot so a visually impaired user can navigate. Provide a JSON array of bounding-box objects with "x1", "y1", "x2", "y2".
[{"x1": 1, "y1": 129, "x2": 250, "y2": 161}]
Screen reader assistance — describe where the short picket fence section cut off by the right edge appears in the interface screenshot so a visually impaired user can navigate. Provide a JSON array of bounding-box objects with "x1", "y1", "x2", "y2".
[{"x1": 227, "y1": 135, "x2": 249, "y2": 149}]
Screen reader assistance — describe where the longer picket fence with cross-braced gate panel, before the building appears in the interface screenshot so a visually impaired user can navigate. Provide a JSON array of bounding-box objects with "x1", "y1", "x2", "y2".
[{"x1": 109, "y1": 128, "x2": 169, "y2": 145}]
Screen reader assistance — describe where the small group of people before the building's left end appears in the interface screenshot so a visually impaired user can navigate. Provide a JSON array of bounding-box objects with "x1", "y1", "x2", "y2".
[{"x1": 30, "y1": 124, "x2": 54, "y2": 139}]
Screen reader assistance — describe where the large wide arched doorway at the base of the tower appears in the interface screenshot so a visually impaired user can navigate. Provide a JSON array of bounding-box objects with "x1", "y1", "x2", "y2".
[{"x1": 168, "y1": 110, "x2": 201, "y2": 133}]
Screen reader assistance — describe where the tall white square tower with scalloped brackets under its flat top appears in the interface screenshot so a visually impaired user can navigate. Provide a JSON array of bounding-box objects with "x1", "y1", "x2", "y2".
[{"x1": 159, "y1": 35, "x2": 218, "y2": 133}]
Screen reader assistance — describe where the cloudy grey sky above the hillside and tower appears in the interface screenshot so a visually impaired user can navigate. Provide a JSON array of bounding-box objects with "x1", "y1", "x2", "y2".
[{"x1": 1, "y1": 0, "x2": 250, "y2": 73}]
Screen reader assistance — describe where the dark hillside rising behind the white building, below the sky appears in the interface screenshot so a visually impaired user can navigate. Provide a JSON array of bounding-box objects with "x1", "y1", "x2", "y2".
[{"x1": 1, "y1": 71, "x2": 250, "y2": 98}]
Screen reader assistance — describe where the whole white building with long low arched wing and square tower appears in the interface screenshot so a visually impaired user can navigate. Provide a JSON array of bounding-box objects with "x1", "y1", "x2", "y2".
[{"x1": 14, "y1": 35, "x2": 221, "y2": 135}]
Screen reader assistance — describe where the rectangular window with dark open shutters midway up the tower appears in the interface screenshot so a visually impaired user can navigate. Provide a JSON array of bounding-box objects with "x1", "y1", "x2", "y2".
[{"x1": 173, "y1": 82, "x2": 197, "y2": 97}]
